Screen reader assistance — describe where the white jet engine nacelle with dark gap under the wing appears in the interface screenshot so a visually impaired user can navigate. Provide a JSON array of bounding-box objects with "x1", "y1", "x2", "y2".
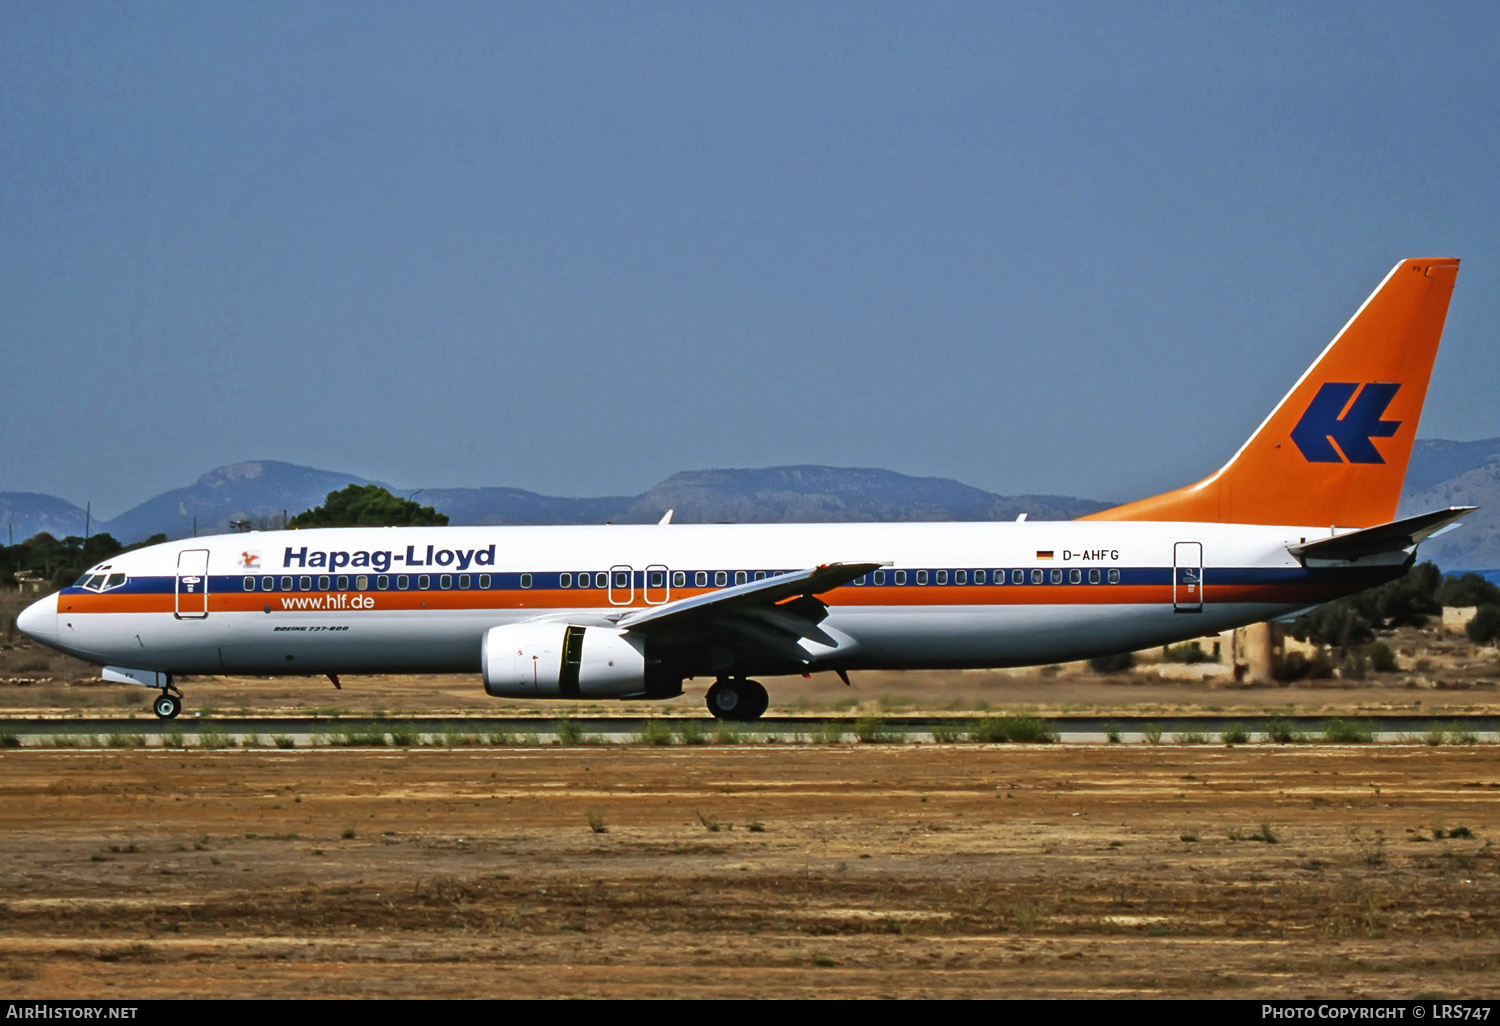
[{"x1": 480, "y1": 623, "x2": 645, "y2": 698}]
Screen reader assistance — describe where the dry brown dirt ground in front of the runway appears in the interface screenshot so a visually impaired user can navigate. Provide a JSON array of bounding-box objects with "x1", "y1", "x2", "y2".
[{"x1": 0, "y1": 744, "x2": 1500, "y2": 999}]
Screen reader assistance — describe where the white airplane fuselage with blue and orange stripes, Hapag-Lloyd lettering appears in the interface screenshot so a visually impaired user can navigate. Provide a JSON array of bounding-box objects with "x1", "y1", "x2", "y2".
[{"x1": 20, "y1": 521, "x2": 1400, "y2": 677}]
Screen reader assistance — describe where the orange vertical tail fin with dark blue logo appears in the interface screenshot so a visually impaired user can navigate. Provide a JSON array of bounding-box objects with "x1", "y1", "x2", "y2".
[{"x1": 1083, "y1": 260, "x2": 1458, "y2": 527}]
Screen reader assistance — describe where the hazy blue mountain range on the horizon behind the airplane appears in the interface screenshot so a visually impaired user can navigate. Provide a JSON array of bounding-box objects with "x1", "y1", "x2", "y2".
[{"x1": 0, "y1": 438, "x2": 1500, "y2": 572}]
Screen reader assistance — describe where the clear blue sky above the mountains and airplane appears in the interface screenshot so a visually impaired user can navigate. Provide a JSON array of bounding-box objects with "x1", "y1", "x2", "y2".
[{"x1": 0, "y1": 0, "x2": 1500, "y2": 515}]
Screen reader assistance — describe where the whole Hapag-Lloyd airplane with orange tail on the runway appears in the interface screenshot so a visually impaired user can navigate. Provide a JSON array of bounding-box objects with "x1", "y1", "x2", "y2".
[{"x1": 17, "y1": 260, "x2": 1473, "y2": 720}]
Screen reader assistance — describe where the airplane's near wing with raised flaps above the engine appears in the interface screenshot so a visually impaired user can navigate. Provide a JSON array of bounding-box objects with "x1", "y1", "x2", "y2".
[{"x1": 615, "y1": 563, "x2": 887, "y2": 666}]
